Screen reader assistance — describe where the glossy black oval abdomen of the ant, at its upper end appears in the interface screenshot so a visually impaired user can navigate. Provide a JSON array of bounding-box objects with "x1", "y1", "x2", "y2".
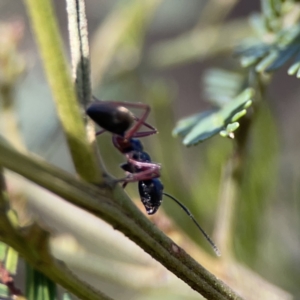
[{"x1": 86, "y1": 101, "x2": 134, "y2": 136}]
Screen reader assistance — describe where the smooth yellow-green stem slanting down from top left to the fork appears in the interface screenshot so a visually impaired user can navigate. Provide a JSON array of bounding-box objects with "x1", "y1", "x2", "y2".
[{"x1": 25, "y1": 0, "x2": 101, "y2": 183}]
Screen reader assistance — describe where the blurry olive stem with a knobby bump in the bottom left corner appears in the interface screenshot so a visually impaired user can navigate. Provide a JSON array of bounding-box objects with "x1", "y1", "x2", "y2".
[{"x1": 0, "y1": 170, "x2": 110, "y2": 300}]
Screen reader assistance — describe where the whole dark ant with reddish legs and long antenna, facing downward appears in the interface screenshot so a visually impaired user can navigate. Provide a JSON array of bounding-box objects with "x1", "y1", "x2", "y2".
[{"x1": 86, "y1": 99, "x2": 220, "y2": 256}]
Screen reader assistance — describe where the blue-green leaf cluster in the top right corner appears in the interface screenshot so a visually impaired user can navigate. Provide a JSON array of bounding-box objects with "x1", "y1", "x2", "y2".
[{"x1": 236, "y1": 0, "x2": 300, "y2": 78}]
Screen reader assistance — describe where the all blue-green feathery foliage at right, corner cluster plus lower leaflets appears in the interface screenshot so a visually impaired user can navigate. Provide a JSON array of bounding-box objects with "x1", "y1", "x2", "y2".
[{"x1": 173, "y1": 0, "x2": 300, "y2": 146}]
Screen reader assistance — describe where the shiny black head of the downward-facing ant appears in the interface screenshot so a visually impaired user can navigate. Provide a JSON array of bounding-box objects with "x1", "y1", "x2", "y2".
[{"x1": 139, "y1": 178, "x2": 164, "y2": 215}]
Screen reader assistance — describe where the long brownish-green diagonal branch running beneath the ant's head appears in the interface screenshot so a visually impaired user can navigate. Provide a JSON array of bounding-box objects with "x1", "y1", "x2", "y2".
[{"x1": 0, "y1": 140, "x2": 241, "y2": 300}]
